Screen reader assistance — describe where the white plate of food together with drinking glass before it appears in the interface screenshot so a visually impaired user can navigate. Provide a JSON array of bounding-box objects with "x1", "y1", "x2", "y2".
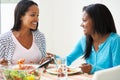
[{"x1": 46, "y1": 57, "x2": 82, "y2": 80}]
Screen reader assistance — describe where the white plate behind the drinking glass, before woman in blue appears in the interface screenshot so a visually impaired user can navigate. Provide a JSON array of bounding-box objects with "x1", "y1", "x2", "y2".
[{"x1": 46, "y1": 68, "x2": 81, "y2": 74}]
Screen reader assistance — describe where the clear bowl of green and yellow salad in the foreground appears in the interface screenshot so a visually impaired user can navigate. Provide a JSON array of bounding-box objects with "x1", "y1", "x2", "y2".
[{"x1": 2, "y1": 64, "x2": 42, "y2": 80}]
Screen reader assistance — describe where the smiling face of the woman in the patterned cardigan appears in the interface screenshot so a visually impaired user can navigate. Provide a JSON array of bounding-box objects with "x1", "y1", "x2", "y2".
[{"x1": 21, "y1": 5, "x2": 39, "y2": 30}]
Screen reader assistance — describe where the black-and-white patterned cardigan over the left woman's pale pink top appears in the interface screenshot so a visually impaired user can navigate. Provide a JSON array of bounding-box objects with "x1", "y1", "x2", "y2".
[{"x1": 0, "y1": 30, "x2": 46, "y2": 63}]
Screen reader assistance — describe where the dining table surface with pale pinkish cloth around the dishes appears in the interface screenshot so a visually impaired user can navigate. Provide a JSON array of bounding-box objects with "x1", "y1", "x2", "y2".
[{"x1": 0, "y1": 65, "x2": 93, "y2": 80}]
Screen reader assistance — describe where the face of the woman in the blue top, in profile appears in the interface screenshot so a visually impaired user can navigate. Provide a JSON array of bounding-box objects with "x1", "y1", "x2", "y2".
[{"x1": 81, "y1": 11, "x2": 93, "y2": 35}]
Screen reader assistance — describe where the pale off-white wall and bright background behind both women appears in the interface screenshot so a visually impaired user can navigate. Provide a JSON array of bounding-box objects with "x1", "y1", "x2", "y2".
[{"x1": 0, "y1": 0, "x2": 120, "y2": 65}]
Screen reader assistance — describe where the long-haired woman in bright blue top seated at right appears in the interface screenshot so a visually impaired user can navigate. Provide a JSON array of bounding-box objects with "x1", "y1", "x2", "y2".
[{"x1": 67, "y1": 4, "x2": 120, "y2": 73}]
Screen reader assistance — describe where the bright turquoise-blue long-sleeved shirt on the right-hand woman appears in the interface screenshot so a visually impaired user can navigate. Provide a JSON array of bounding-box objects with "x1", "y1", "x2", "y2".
[{"x1": 67, "y1": 33, "x2": 120, "y2": 73}]
